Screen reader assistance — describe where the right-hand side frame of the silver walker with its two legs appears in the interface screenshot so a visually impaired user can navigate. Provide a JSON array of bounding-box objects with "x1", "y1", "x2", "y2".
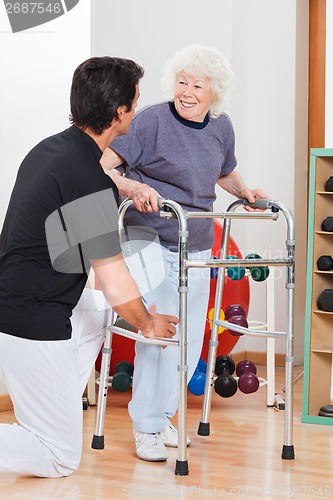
[{"x1": 196, "y1": 200, "x2": 295, "y2": 460}]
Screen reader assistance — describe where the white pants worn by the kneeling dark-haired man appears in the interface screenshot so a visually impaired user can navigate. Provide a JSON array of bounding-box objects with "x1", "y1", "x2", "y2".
[{"x1": 0, "y1": 289, "x2": 108, "y2": 477}]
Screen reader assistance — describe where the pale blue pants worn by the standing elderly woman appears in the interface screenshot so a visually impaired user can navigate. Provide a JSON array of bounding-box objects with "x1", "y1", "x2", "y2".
[{"x1": 128, "y1": 243, "x2": 211, "y2": 432}]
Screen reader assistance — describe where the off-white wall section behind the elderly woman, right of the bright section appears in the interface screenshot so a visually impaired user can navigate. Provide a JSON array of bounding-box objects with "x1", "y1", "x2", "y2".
[{"x1": 92, "y1": 0, "x2": 308, "y2": 357}]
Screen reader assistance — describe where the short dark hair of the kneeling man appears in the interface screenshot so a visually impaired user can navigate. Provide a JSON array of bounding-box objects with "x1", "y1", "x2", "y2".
[{"x1": 69, "y1": 56, "x2": 144, "y2": 135}]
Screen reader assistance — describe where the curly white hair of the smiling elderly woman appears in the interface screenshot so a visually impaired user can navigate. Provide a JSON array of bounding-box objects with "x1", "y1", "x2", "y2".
[{"x1": 161, "y1": 44, "x2": 234, "y2": 118}]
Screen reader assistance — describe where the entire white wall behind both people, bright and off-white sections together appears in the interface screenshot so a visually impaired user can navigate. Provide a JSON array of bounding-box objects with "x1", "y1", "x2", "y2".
[{"x1": 0, "y1": 0, "x2": 308, "y2": 362}]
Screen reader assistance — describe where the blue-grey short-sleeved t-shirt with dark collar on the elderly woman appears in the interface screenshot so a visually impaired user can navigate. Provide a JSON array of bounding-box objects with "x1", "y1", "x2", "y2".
[{"x1": 110, "y1": 102, "x2": 237, "y2": 251}]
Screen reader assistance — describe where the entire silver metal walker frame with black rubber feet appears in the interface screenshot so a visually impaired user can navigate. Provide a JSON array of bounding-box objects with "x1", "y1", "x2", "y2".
[{"x1": 91, "y1": 198, "x2": 295, "y2": 476}]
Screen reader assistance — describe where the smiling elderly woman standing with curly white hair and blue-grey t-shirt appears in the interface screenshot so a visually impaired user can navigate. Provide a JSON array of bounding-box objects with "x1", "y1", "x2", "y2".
[{"x1": 102, "y1": 45, "x2": 267, "y2": 461}]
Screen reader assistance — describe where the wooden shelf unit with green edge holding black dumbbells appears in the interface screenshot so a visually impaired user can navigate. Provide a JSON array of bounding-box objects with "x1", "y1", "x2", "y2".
[{"x1": 301, "y1": 148, "x2": 333, "y2": 425}]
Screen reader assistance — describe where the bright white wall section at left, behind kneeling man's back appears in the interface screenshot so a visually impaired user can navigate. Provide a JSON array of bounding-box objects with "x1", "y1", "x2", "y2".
[{"x1": 0, "y1": 0, "x2": 91, "y2": 227}]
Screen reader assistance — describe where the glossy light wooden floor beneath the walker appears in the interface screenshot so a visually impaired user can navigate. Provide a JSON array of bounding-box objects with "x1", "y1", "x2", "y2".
[{"x1": 0, "y1": 367, "x2": 333, "y2": 500}]
